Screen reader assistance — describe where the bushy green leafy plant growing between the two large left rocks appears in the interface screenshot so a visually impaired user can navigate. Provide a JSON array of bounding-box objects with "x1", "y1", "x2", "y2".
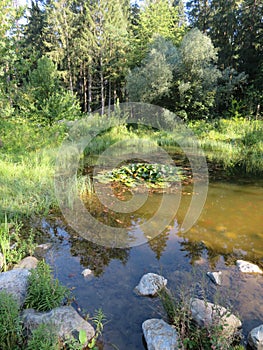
[{"x1": 25, "y1": 261, "x2": 69, "y2": 311}]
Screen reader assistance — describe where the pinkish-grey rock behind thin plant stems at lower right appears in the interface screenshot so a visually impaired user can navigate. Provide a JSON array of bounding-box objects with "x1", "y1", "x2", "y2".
[{"x1": 190, "y1": 298, "x2": 242, "y2": 337}]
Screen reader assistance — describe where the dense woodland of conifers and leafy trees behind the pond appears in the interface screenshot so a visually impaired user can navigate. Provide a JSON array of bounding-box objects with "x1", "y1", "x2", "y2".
[{"x1": 0, "y1": 0, "x2": 263, "y2": 124}]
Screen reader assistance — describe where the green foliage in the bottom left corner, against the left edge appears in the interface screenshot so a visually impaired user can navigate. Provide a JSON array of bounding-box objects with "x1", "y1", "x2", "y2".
[{"x1": 0, "y1": 291, "x2": 22, "y2": 350}]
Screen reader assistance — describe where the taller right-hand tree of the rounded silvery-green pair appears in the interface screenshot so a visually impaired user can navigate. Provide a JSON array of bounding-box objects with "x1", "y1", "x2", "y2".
[{"x1": 175, "y1": 28, "x2": 221, "y2": 119}]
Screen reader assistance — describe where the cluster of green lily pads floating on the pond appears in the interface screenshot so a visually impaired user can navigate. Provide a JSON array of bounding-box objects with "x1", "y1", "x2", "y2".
[{"x1": 94, "y1": 163, "x2": 185, "y2": 188}]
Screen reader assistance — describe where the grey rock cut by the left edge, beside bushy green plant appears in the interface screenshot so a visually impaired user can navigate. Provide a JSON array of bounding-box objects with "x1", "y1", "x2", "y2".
[{"x1": 0, "y1": 269, "x2": 30, "y2": 306}]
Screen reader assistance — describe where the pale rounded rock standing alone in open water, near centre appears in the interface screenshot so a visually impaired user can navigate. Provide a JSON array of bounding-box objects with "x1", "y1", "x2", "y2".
[{"x1": 135, "y1": 273, "x2": 167, "y2": 296}]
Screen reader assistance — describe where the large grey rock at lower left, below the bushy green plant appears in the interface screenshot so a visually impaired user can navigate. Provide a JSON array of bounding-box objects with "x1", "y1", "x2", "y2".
[{"x1": 22, "y1": 306, "x2": 95, "y2": 341}]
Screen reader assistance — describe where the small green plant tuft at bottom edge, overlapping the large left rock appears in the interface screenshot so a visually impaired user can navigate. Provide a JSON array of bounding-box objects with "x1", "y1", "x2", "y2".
[{"x1": 26, "y1": 323, "x2": 61, "y2": 350}]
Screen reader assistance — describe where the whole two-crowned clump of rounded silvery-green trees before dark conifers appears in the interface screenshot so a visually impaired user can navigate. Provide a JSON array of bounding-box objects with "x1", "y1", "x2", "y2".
[{"x1": 127, "y1": 28, "x2": 221, "y2": 119}]
